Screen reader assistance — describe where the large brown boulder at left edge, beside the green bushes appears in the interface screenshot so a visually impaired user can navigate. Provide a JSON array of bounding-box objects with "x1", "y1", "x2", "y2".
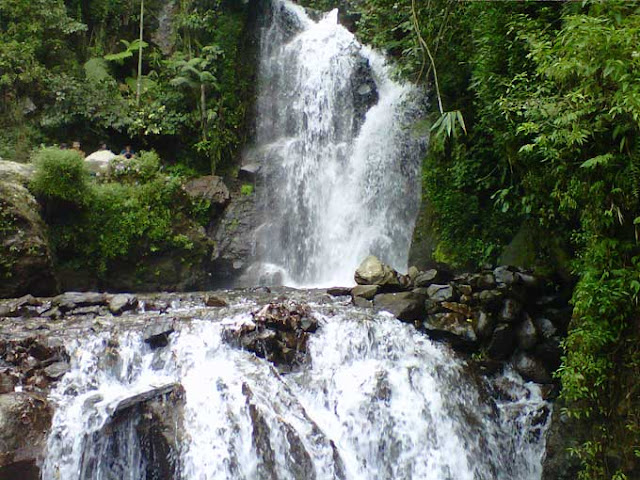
[{"x1": 0, "y1": 161, "x2": 58, "y2": 298}]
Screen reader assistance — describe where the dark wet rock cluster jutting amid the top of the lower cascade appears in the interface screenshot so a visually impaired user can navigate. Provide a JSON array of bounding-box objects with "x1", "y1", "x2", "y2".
[{"x1": 227, "y1": 301, "x2": 318, "y2": 368}]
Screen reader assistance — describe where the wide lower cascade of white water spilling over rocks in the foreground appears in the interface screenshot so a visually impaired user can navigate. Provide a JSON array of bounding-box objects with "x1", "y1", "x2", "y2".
[{"x1": 42, "y1": 292, "x2": 548, "y2": 480}]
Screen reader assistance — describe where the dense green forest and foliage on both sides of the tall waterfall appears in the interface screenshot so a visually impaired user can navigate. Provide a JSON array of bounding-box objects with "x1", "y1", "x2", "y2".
[{"x1": 0, "y1": 0, "x2": 640, "y2": 480}]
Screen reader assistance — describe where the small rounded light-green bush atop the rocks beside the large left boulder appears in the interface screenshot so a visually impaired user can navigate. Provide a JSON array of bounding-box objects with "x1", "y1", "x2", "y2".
[{"x1": 31, "y1": 147, "x2": 89, "y2": 205}]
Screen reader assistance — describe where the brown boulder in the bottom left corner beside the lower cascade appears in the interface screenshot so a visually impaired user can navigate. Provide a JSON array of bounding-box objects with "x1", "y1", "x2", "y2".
[{"x1": 0, "y1": 392, "x2": 52, "y2": 480}]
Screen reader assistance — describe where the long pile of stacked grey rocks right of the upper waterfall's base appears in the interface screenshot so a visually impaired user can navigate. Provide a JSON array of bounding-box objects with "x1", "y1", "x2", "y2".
[{"x1": 334, "y1": 256, "x2": 571, "y2": 383}]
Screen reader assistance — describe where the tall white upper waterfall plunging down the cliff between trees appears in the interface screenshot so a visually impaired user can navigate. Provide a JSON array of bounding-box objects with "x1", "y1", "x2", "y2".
[{"x1": 247, "y1": 0, "x2": 423, "y2": 286}]
